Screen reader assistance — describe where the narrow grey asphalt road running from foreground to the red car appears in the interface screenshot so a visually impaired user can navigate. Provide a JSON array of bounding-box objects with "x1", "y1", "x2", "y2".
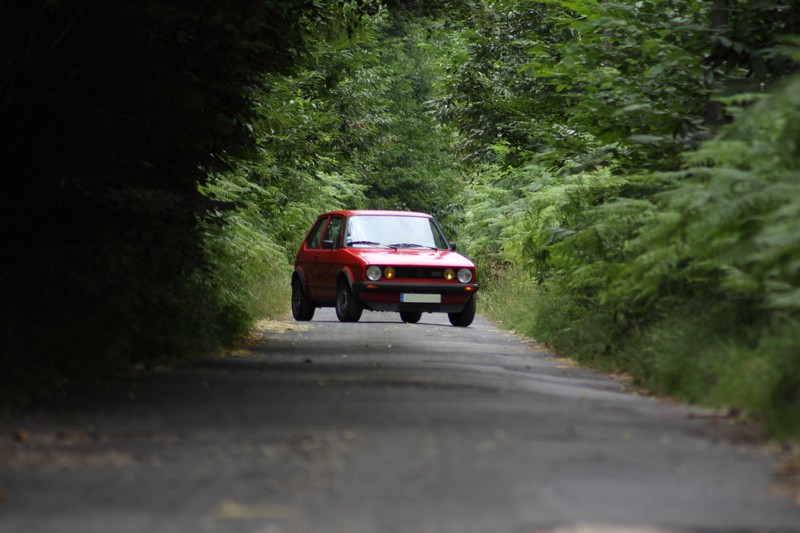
[{"x1": 0, "y1": 310, "x2": 800, "y2": 533}]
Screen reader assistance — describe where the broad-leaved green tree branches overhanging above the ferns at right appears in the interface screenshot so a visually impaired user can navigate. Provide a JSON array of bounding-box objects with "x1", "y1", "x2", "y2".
[{"x1": 439, "y1": 0, "x2": 800, "y2": 171}]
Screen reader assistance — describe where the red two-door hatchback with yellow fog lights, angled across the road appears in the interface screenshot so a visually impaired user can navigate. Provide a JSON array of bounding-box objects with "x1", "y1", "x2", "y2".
[{"x1": 292, "y1": 211, "x2": 478, "y2": 327}]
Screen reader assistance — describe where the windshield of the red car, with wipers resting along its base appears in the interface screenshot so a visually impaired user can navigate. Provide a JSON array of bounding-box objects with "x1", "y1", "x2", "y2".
[{"x1": 345, "y1": 215, "x2": 447, "y2": 249}]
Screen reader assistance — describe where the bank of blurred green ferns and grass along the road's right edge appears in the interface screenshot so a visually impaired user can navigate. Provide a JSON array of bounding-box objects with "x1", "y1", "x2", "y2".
[{"x1": 482, "y1": 69, "x2": 800, "y2": 434}]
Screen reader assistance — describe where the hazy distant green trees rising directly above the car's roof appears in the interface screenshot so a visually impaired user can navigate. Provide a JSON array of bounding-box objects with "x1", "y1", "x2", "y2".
[{"x1": 324, "y1": 16, "x2": 461, "y2": 219}]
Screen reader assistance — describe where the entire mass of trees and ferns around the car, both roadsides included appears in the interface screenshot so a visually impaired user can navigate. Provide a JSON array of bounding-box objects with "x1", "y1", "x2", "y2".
[{"x1": 0, "y1": 0, "x2": 800, "y2": 435}]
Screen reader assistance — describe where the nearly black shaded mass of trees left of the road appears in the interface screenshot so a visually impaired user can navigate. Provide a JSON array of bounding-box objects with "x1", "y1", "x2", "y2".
[{"x1": 0, "y1": 0, "x2": 360, "y2": 390}]
